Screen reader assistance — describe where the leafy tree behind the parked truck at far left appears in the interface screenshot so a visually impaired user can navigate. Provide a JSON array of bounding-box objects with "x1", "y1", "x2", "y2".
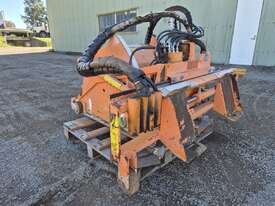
[{"x1": 21, "y1": 0, "x2": 47, "y2": 28}]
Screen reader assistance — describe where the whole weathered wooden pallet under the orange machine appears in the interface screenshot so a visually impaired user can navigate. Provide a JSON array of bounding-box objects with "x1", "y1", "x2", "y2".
[{"x1": 64, "y1": 117, "x2": 210, "y2": 171}]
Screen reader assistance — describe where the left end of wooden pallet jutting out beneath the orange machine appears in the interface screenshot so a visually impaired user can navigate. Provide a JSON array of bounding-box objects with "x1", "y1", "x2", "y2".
[{"x1": 63, "y1": 117, "x2": 111, "y2": 161}]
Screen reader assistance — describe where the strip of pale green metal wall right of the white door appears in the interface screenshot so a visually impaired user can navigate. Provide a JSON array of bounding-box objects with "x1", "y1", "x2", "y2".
[{"x1": 253, "y1": 0, "x2": 275, "y2": 66}]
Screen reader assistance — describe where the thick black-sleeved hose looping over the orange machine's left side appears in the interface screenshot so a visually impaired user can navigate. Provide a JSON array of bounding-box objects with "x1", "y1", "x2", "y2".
[{"x1": 77, "y1": 12, "x2": 206, "y2": 92}]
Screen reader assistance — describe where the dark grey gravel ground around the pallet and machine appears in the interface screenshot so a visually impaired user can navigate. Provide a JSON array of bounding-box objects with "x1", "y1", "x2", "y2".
[{"x1": 0, "y1": 50, "x2": 275, "y2": 205}]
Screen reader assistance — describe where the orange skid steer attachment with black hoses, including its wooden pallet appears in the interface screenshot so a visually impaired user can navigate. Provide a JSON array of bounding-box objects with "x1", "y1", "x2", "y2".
[{"x1": 64, "y1": 6, "x2": 245, "y2": 195}]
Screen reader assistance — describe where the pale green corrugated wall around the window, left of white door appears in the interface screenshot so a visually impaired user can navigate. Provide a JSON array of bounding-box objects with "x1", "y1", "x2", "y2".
[{"x1": 47, "y1": 0, "x2": 237, "y2": 63}]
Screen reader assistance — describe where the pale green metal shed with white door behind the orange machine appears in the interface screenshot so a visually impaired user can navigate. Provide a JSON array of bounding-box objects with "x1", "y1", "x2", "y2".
[{"x1": 47, "y1": 0, "x2": 275, "y2": 66}]
